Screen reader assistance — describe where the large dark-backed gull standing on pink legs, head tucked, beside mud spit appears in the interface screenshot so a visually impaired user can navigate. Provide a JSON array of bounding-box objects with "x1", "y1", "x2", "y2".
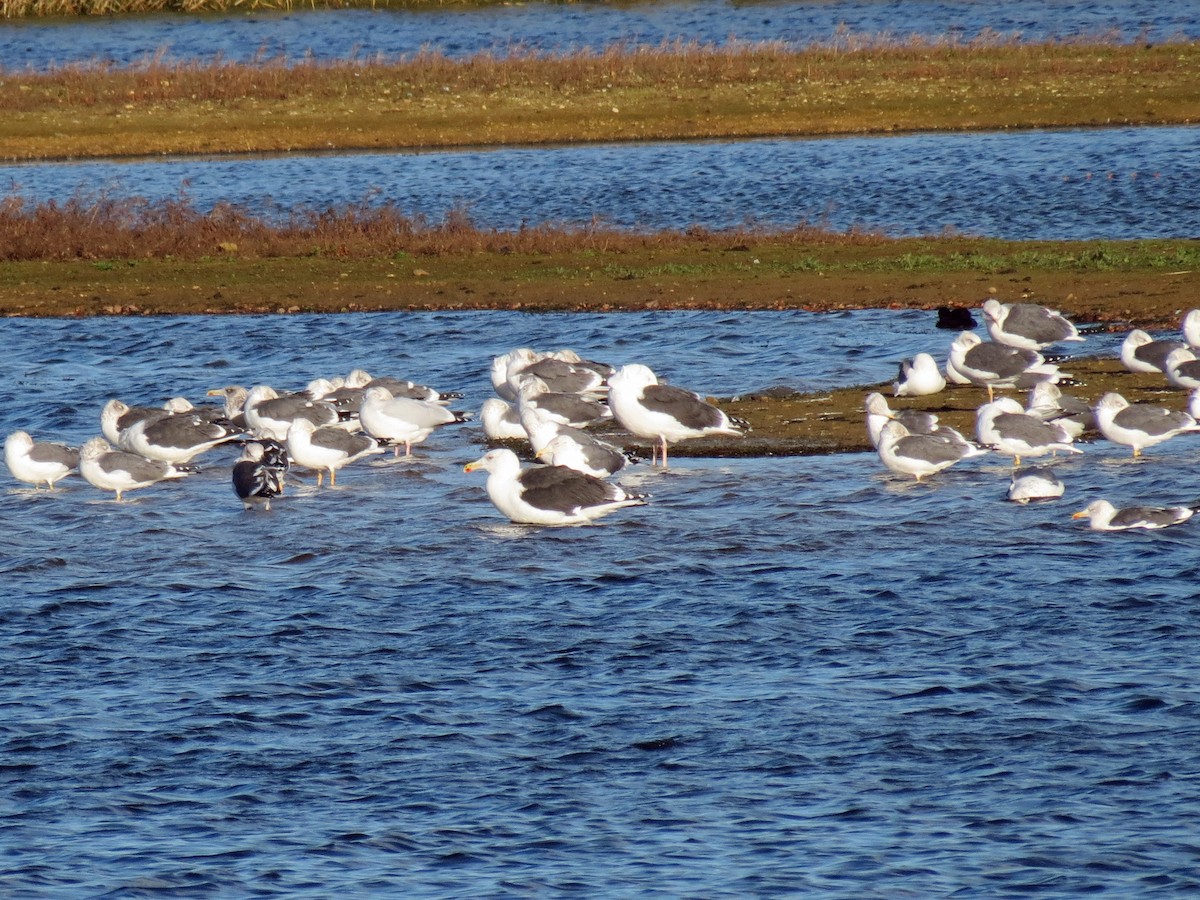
[{"x1": 608, "y1": 362, "x2": 742, "y2": 469}]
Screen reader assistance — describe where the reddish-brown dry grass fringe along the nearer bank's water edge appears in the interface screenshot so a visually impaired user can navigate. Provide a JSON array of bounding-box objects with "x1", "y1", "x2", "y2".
[{"x1": 0, "y1": 190, "x2": 882, "y2": 260}]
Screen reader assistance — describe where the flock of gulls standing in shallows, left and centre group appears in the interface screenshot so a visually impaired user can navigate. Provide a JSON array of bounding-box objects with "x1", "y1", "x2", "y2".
[{"x1": 5, "y1": 348, "x2": 744, "y2": 526}]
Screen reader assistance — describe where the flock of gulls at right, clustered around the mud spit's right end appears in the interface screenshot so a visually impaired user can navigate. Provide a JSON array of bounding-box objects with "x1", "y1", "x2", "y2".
[{"x1": 865, "y1": 299, "x2": 1200, "y2": 530}]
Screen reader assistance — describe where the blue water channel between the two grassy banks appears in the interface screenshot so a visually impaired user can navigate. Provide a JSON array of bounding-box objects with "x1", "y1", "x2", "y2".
[{"x1": 0, "y1": 127, "x2": 1200, "y2": 240}]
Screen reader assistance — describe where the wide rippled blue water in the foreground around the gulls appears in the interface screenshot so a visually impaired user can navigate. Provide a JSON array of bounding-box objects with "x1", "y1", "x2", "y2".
[{"x1": 0, "y1": 312, "x2": 1200, "y2": 896}]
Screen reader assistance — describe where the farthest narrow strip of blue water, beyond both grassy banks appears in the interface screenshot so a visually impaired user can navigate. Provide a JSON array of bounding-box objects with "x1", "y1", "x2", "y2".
[{"x1": 0, "y1": 0, "x2": 1200, "y2": 68}]
